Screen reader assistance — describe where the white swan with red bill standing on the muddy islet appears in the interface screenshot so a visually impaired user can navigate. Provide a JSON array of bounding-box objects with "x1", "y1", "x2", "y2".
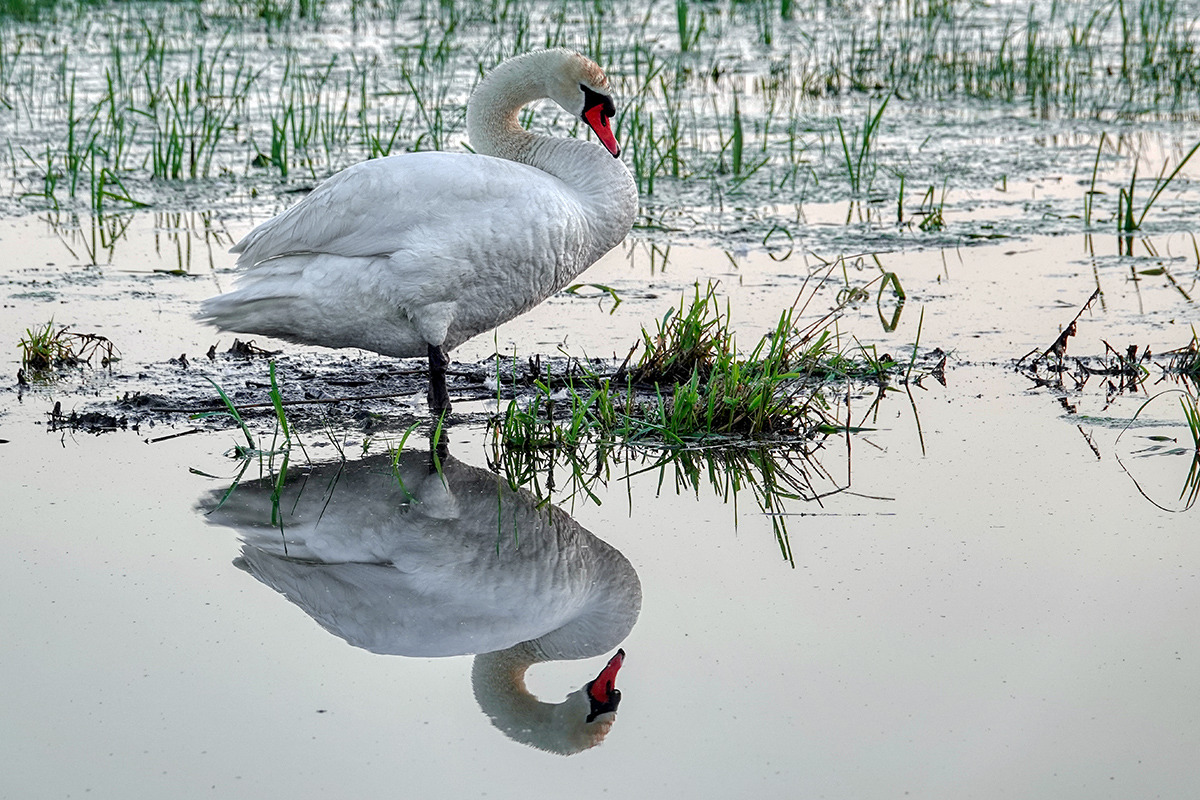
[{"x1": 198, "y1": 49, "x2": 637, "y2": 414}]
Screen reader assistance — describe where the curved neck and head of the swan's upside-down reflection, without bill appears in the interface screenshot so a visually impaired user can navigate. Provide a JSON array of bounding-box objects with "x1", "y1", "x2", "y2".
[{"x1": 470, "y1": 642, "x2": 617, "y2": 756}]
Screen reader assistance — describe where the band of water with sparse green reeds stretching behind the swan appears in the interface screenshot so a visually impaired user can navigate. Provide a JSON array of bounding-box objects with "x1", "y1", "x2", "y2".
[{"x1": 0, "y1": 0, "x2": 1200, "y2": 254}]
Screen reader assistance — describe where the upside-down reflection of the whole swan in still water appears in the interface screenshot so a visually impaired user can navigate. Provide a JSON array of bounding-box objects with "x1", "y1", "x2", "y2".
[{"x1": 200, "y1": 451, "x2": 642, "y2": 754}]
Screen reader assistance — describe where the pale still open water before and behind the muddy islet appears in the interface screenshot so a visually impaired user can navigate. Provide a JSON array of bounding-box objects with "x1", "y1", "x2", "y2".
[{"x1": 0, "y1": 203, "x2": 1200, "y2": 798}]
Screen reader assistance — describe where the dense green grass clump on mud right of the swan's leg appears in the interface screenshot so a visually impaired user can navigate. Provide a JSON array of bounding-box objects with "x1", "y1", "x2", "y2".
[{"x1": 492, "y1": 275, "x2": 896, "y2": 450}]
